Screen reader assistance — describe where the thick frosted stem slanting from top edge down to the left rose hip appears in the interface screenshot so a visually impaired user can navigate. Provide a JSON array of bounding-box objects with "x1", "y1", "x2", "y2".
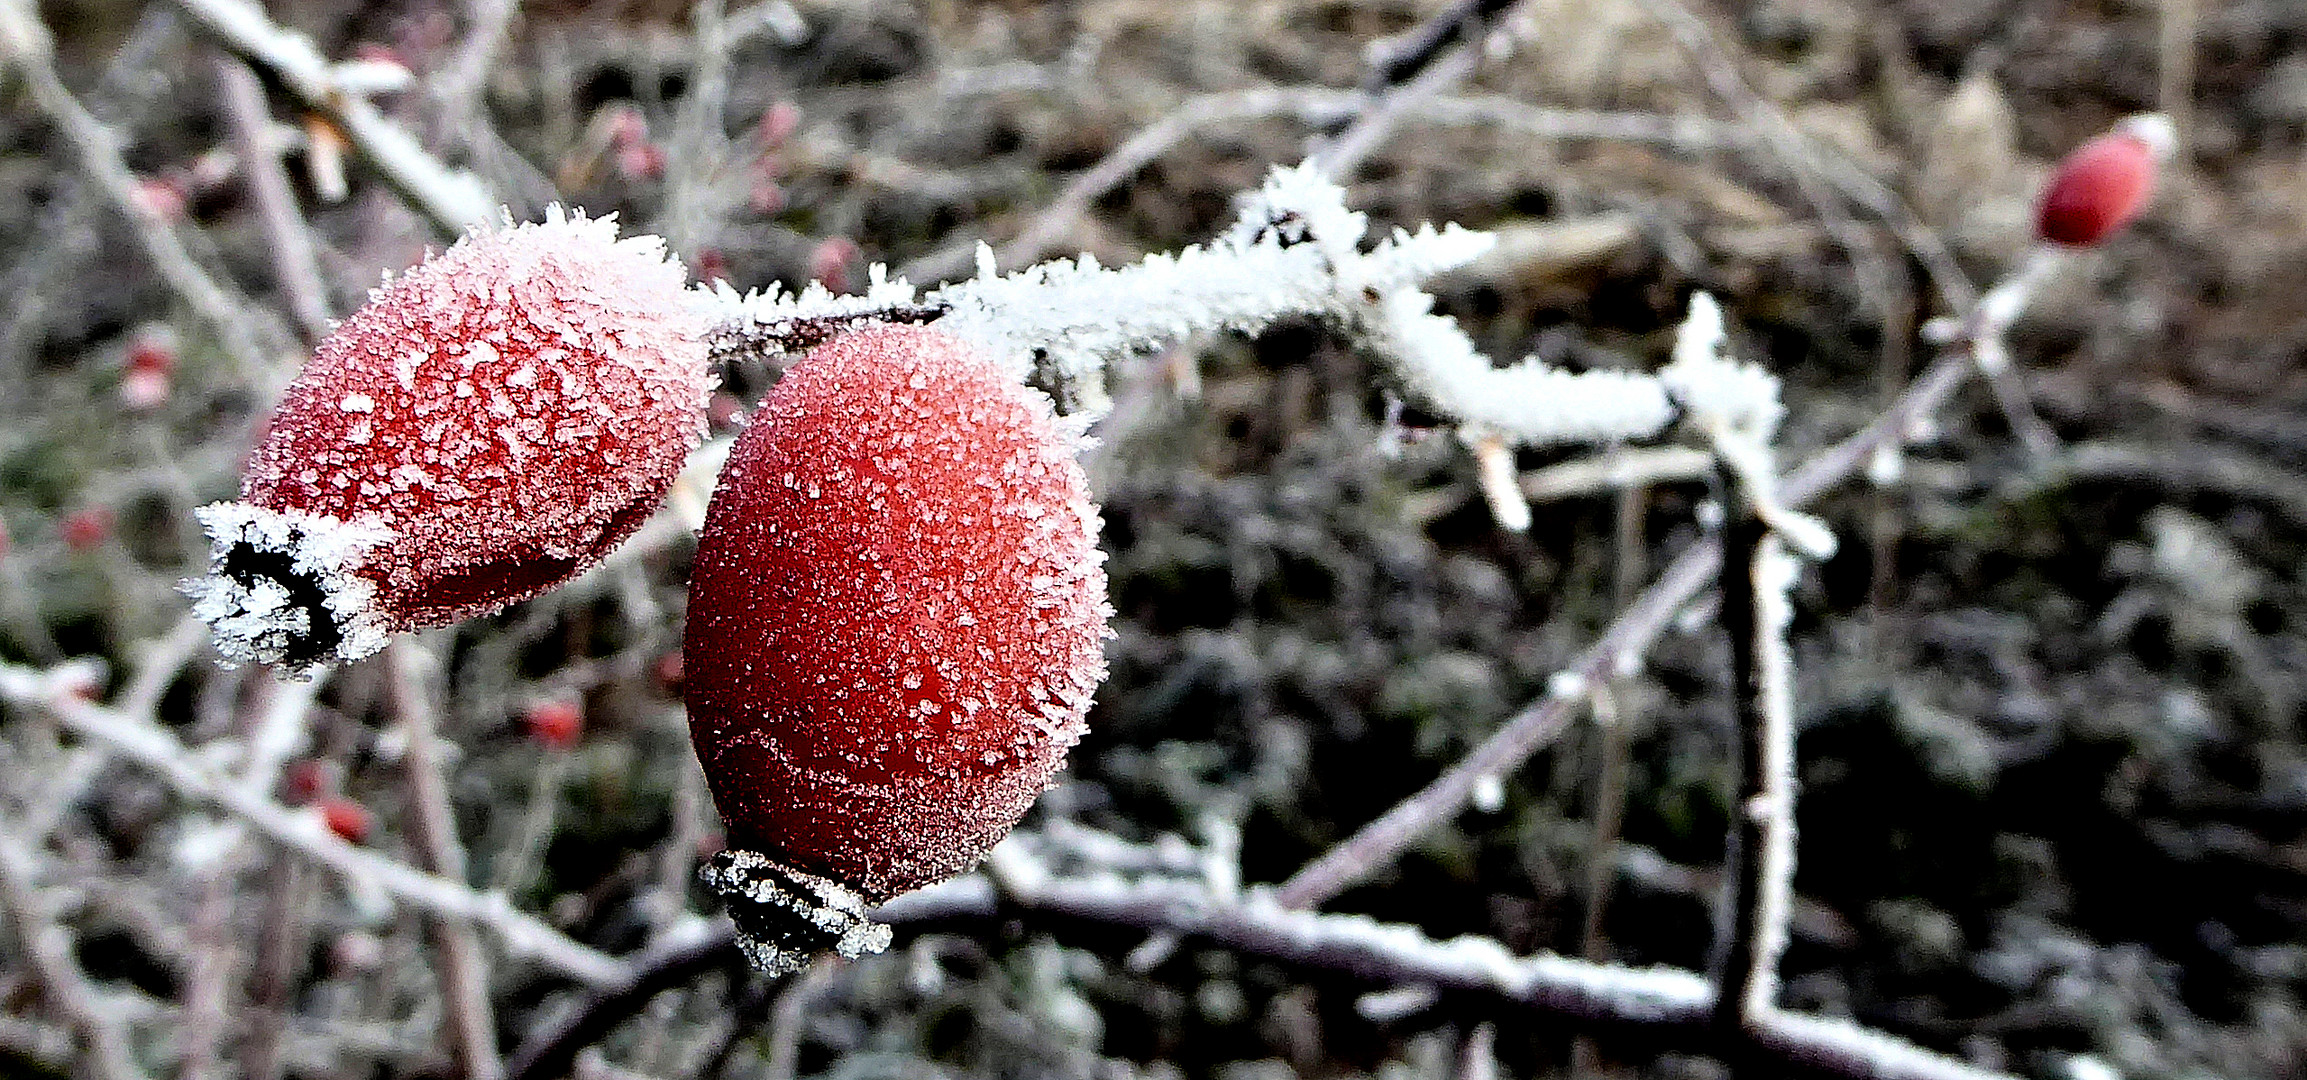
[{"x1": 175, "y1": 0, "x2": 496, "y2": 235}]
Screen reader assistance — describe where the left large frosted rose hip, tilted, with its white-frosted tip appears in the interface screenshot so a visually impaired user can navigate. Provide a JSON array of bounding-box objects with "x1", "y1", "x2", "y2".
[{"x1": 187, "y1": 208, "x2": 713, "y2": 669}]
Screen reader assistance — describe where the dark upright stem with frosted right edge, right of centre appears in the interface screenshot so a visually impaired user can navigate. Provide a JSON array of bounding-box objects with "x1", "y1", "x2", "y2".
[{"x1": 1714, "y1": 462, "x2": 1795, "y2": 1029}]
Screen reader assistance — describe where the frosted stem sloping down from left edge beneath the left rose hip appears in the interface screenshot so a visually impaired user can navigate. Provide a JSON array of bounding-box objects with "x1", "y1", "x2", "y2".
[{"x1": 0, "y1": 665, "x2": 625, "y2": 985}]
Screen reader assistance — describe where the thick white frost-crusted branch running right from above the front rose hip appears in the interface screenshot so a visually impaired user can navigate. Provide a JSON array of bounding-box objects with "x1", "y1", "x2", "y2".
[{"x1": 704, "y1": 166, "x2": 1675, "y2": 443}]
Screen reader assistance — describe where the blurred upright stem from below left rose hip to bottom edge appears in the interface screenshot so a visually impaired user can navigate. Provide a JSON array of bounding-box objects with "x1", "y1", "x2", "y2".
[{"x1": 385, "y1": 637, "x2": 503, "y2": 1080}]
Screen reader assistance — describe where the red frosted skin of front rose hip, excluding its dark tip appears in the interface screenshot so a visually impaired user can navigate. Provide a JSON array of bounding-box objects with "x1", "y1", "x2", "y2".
[{"x1": 683, "y1": 328, "x2": 1112, "y2": 902}]
